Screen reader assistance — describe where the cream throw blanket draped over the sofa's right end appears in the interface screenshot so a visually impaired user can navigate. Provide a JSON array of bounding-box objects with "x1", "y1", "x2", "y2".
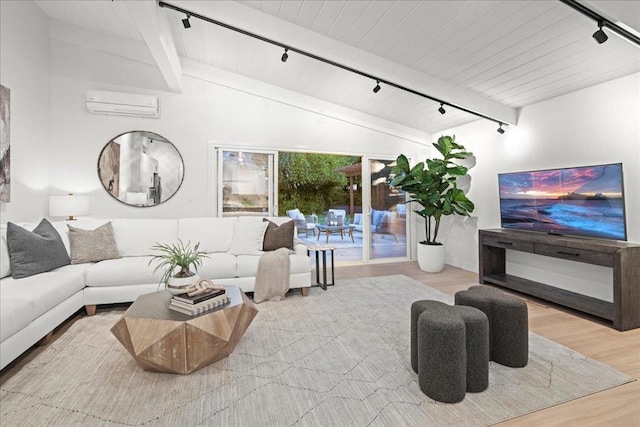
[{"x1": 253, "y1": 248, "x2": 291, "y2": 303}]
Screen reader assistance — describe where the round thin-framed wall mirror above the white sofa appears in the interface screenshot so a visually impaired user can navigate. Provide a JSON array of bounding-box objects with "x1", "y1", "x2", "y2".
[{"x1": 98, "y1": 131, "x2": 184, "y2": 207}]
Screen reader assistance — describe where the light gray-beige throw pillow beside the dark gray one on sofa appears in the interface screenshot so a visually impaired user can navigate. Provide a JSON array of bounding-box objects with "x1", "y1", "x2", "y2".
[{"x1": 67, "y1": 222, "x2": 120, "y2": 264}]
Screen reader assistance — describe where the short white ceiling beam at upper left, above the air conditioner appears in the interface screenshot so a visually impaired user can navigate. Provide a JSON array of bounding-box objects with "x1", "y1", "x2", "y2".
[{"x1": 124, "y1": 0, "x2": 182, "y2": 93}]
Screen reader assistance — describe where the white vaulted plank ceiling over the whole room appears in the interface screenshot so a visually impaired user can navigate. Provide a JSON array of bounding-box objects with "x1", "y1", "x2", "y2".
[{"x1": 36, "y1": 0, "x2": 640, "y2": 133}]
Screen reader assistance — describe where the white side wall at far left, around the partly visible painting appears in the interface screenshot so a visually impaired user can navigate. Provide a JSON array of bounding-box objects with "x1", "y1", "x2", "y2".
[{"x1": 0, "y1": 1, "x2": 50, "y2": 223}]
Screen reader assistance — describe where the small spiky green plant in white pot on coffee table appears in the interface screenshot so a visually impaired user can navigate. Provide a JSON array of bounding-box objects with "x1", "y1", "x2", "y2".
[{"x1": 149, "y1": 239, "x2": 209, "y2": 295}]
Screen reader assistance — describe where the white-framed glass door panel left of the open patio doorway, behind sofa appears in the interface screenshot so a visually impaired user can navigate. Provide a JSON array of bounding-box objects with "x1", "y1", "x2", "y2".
[{"x1": 216, "y1": 148, "x2": 278, "y2": 216}]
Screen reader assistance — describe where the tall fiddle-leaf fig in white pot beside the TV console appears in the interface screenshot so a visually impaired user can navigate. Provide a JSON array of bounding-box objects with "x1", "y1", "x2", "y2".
[{"x1": 387, "y1": 136, "x2": 475, "y2": 273}]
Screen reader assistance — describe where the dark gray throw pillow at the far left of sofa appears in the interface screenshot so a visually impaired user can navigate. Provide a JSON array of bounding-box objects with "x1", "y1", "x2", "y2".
[{"x1": 7, "y1": 219, "x2": 71, "y2": 279}]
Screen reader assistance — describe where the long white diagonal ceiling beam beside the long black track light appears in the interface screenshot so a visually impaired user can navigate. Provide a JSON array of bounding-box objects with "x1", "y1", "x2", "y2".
[{"x1": 167, "y1": 0, "x2": 517, "y2": 125}]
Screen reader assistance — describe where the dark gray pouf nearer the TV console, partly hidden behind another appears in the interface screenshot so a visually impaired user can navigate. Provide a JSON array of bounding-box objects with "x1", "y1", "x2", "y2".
[{"x1": 455, "y1": 286, "x2": 529, "y2": 368}]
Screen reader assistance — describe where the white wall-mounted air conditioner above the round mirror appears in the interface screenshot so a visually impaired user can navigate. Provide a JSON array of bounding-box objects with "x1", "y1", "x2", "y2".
[{"x1": 87, "y1": 90, "x2": 160, "y2": 119}]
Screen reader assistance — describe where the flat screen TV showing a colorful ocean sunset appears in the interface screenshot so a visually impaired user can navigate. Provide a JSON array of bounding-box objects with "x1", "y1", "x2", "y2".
[{"x1": 498, "y1": 163, "x2": 627, "y2": 240}]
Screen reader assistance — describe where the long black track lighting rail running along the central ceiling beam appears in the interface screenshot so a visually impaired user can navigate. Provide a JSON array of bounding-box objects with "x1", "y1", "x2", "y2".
[{"x1": 158, "y1": 1, "x2": 508, "y2": 130}]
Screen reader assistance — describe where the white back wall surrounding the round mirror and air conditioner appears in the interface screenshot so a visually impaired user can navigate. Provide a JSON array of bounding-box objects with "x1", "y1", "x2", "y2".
[{"x1": 51, "y1": 40, "x2": 424, "y2": 218}]
